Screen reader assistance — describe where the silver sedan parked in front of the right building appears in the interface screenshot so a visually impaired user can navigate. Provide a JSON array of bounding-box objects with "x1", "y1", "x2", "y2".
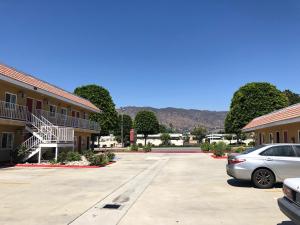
[{"x1": 226, "y1": 144, "x2": 300, "y2": 188}]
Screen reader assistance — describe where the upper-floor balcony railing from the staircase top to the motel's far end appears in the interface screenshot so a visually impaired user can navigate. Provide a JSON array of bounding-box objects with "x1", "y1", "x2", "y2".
[{"x1": 34, "y1": 110, "x2": 100, "y2": 131}]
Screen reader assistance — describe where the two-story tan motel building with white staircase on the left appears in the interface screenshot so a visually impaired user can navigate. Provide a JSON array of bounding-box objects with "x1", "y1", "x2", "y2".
[{"x1": 0, "y1": 64, "x2": 100, "y2": 162}]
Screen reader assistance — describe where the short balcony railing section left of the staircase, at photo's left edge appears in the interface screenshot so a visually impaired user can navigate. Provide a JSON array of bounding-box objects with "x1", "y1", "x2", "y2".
[{"x1": 0, "y1": 101, "x2": 28, "y2": 121}]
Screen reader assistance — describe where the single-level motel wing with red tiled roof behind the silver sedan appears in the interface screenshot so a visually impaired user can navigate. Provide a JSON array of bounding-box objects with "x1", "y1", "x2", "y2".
[{"x1": 242, "y1": 104, "x2": 300, "y2": 145}]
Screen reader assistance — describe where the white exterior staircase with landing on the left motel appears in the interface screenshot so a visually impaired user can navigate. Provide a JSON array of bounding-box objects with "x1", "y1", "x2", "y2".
[{"x1": 19, "y1": 112, "x2": 74, "y2": 163}]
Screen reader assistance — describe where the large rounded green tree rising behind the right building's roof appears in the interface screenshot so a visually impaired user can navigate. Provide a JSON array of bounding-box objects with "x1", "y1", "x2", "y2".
[{"x1": 225, "y1": 82, "x2": 288, "y2": 136}]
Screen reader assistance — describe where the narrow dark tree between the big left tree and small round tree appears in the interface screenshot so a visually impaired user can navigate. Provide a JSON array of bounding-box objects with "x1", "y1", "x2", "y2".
[{"x1": 114, "y1": 114, "x2": 133, "y2": 146}]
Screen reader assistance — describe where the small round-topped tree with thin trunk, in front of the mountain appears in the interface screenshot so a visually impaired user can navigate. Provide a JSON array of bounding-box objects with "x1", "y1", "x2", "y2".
[{"x1": 134, "y1": 110, "x2": 159, "y2": 146}]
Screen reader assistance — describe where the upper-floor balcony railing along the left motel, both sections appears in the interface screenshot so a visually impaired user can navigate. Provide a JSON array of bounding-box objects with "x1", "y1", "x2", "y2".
[{"x1": 0, "y1": 101, "x2": 100, "y2": 131}]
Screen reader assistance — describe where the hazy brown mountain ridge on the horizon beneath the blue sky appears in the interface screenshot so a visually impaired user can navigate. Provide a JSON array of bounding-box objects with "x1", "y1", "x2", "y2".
[{"x1": 118, "y1": 106, "x2": 227, "y2": 131}]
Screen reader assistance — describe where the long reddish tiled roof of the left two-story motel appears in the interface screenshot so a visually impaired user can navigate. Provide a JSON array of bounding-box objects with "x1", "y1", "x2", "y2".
[{"x1": 0, "y1": 64, "x2": 100, "y2": 112}]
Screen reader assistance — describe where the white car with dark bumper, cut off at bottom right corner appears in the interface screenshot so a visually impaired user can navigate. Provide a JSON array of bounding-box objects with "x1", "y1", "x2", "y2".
[{"x1": 277, "y1": 178, "x2": 300, "y2": 225}]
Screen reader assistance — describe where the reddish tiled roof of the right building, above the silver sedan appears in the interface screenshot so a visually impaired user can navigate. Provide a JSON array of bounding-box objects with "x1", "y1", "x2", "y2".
[{"x1": 243, "y1": 104, "x2": 300, "y2": 130}]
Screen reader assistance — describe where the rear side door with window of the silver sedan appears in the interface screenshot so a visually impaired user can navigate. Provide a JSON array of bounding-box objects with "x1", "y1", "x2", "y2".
[{"x1": 261, "y1": 145, "x2": 300, "y2": 180}]
